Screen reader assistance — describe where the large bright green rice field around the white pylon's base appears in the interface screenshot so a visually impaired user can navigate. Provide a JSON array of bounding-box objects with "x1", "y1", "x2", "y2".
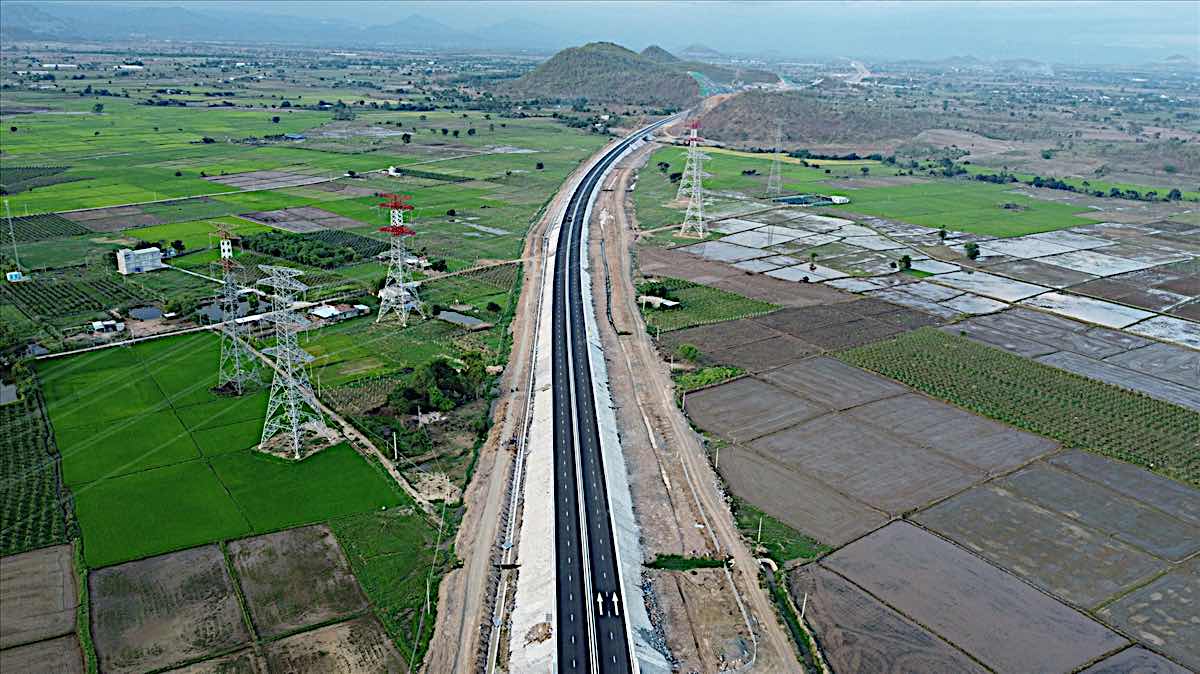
[{"x1": 37, "y1": 333, "x2": 406, "y2": 567}]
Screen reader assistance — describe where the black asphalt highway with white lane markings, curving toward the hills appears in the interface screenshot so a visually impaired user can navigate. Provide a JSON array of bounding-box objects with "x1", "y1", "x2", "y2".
[{"x1": 551, "y1": 120, "x2": 668, "y2": 674}]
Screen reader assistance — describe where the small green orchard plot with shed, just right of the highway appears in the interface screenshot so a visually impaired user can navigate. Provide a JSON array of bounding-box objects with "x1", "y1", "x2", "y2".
[{"x1": 637, "y1": 278, "x2": 779, "y2": 332}]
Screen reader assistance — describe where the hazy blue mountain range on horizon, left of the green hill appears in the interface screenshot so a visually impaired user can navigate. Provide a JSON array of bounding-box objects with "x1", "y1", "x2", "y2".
[{"x1": 0, "y1": 2, "x2": 564, "y2": 52}]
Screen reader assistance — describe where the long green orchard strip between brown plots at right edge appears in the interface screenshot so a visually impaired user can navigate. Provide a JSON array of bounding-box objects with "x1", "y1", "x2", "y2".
[{"x1": 839, "y1": 327, "x2": 1200, "y2": 486}]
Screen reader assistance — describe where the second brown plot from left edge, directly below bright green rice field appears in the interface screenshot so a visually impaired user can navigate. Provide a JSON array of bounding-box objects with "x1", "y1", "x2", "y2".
[{"x1": 89, "y1": 546, "x2": 251, "y2": 673}]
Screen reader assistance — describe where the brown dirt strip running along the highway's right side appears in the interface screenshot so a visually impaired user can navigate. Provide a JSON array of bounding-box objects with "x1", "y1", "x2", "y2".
[{"x1": 592, "y1": 140, "x2": 800, "y2": 672}]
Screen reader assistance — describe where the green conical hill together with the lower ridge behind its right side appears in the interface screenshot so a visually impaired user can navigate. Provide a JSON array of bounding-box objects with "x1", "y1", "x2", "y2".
[{"x1": 498, "y1": 42, "x2": 779, "y2": 108}]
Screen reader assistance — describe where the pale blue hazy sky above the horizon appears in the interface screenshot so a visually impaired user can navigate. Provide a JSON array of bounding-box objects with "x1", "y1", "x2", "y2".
[{"x1": 35, "y1": 0, "x2": 1200, "y2": 62}]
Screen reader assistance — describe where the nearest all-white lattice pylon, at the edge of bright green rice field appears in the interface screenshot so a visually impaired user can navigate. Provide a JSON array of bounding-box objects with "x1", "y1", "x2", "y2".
[{"x1": 258, "y1": 265, "x2": 325, "y2": 459}]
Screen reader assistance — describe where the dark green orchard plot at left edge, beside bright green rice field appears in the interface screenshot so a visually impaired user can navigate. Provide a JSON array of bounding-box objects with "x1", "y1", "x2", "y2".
[{"x1": 0, "y1": 381, "x2": 68, "y2": 555}]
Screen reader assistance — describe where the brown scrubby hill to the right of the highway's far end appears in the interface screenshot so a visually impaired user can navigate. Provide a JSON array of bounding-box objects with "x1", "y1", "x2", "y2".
[{"x1": 701, "y1": 90, "x2": 944, "y2": 152}]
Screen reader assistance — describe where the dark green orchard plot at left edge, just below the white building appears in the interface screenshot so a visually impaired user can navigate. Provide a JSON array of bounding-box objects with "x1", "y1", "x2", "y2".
[{"x1": 0, "y1": 275, "x2": 144, "y2": 319}]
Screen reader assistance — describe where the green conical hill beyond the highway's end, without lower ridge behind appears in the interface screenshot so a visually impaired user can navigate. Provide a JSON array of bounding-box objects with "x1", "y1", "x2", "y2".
[{"x1": 500, "y1": 42, "x2": 700, "y2": 108}]
